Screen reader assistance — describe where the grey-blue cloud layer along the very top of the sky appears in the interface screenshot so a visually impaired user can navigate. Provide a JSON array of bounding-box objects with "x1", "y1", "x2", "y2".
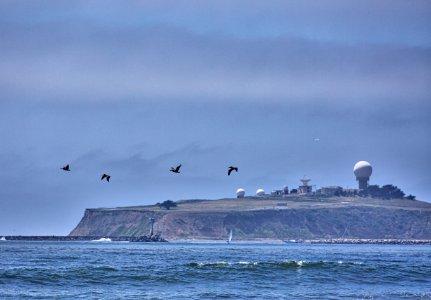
[{"x1": 1, "y1": 0, "x2": 431, "y2": 46}]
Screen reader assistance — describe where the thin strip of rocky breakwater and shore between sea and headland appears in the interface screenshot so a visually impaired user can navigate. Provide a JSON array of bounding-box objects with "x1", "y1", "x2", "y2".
[{"x1": 0, "y1": 235, "x2": 431, "y2": 245}]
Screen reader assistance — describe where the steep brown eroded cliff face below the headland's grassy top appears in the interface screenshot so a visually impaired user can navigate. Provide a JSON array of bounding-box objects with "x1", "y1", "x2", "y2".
[{"x1": 70, "y1": 201, "x2": 431, "y2": 240}]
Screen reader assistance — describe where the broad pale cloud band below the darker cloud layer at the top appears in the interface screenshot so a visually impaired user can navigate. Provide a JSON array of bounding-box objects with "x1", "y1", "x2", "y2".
[{"x1": 0, "y1": 26, "x2": 431, "y2": 103}]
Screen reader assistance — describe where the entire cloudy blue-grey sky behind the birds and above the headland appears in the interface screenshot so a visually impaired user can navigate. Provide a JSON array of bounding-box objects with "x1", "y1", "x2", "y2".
[{"x1": 0, "y1": 0, "x2": 431, "y2": 235}]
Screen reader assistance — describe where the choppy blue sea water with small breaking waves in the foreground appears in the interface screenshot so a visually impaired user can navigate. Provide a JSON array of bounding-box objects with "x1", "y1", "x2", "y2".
[{"x1": 0, "y1": 241, "x2": 431, "y2": 299}]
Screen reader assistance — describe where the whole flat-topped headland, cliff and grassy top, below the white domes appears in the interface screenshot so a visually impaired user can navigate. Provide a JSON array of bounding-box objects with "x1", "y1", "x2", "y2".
[{"x1": 69, "y1": 195, "x2": 431, "y2": 244}]
